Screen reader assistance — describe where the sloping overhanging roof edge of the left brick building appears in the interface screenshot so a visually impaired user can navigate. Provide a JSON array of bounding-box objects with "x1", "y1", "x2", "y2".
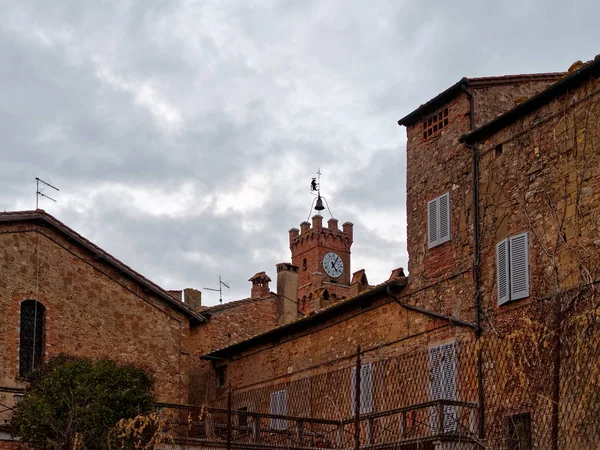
[{"x1": 0, "y1": 209, "x2": 206, "y2": 322}]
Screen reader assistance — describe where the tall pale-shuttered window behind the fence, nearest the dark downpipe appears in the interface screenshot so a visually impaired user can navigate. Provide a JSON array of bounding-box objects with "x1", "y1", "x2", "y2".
[{"x1": 429, "y1": 342, "x2": 458, "y2": 434}]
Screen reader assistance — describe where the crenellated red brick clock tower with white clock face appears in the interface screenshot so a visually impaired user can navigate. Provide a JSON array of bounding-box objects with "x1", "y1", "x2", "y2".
[{"x1": 289, "y1": 214, "x2": 354, "y2": 314}]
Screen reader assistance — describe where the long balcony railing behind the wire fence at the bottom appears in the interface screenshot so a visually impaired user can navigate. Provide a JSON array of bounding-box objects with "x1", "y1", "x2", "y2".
[{"x1": 159, "y1": 400, "x2": 479, "y2": 450}]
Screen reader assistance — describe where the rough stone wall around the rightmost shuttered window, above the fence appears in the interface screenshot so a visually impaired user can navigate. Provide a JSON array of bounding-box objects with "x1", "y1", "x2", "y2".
[{"x1": 479, "y1": 74, "x2": 600, "y2": 329}]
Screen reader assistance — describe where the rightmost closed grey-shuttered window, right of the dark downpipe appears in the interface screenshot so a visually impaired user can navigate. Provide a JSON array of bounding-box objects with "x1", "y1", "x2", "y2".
[{"x1": 496, "y1": 233, "x2": 529, "y2": 305}]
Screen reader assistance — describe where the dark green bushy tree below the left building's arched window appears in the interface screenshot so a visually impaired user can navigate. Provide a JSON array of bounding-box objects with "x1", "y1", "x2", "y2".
[{"x1": 12, "y1": 355, "x2": 154, "y2": 450}]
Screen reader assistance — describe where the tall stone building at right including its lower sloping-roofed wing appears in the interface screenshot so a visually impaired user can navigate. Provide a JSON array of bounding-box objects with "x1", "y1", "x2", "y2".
[{"x1": 199, "y1": 58, "x2": 600, "y2": 448}]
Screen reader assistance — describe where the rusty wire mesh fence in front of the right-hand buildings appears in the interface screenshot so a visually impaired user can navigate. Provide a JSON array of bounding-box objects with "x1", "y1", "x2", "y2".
[{"x1": 162, "y1": 296, "x2": 600, "y2": 450}]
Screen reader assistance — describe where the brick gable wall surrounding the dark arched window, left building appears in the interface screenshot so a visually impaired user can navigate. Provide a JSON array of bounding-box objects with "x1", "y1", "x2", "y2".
[{"x1": 0, "y1": 223, "x2": 189, "y2": 402}]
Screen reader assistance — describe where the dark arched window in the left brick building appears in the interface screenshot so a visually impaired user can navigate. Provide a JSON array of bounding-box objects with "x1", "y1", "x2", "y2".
[{"x1": 19, "y1": 300, "x2": 46, "y2": 376}]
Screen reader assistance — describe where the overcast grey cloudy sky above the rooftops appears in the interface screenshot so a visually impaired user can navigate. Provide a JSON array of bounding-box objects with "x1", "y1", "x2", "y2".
[{"x1": 0, "y1": 0, "x2": 600, "y2": 304}]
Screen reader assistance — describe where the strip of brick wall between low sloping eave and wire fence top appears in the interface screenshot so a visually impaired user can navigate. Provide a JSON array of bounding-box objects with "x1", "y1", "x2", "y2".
[{"x1": 209, "y1": 284, "x2": 469, "y2": 399}]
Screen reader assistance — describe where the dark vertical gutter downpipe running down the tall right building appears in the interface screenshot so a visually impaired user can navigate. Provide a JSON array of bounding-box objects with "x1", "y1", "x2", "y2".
[{"x1": 462, "y1": 84, "x2": 485, "y2": 442}]
